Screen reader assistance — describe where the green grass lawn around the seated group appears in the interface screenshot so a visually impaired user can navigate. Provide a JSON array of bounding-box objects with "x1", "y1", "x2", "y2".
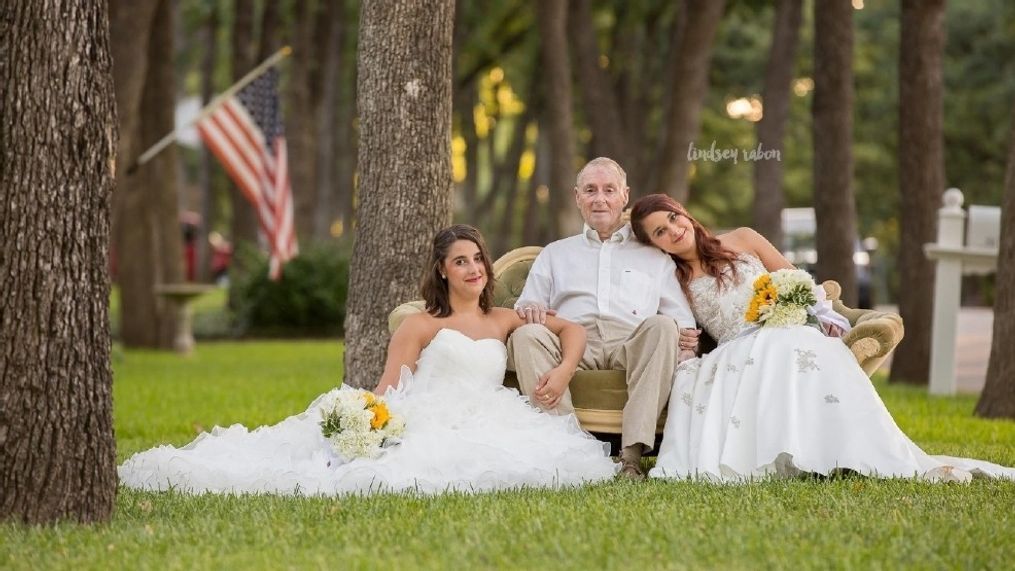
[{"x1": 0, "y1": 342, "x2": 1015, "y2": 570}]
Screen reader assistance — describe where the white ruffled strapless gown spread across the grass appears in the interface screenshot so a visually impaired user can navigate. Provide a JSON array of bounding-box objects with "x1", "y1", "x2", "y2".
[{"x1": 119, "y1": 329, "x2": 617, "y2": 495}]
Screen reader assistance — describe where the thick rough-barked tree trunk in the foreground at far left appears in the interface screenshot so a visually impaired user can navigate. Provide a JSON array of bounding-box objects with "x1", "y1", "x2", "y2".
[{"x1": 0, "y1": 0, "x2": 117, "y2": 523}]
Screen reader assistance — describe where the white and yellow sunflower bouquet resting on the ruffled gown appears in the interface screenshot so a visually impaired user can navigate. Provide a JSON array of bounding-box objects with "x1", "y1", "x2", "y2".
[{"x1": 321, "y1": 389, "x2": 405, "y2": 460}]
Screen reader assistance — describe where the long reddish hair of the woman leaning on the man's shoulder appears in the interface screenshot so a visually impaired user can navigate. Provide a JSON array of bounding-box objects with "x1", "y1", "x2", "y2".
[{"x1": 631, "y1": 195, "x2": 737, "y2": 298}]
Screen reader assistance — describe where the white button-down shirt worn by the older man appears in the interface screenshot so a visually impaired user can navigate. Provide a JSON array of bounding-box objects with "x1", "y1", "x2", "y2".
[{"x1": 515, "y1": 224, "x2": 694, "y2": 331}]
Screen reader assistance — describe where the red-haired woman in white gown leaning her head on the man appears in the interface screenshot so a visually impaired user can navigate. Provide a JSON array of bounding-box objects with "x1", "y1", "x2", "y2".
[{"x1": 631, "y1": 195, "x2": 1015, "y2": 481}]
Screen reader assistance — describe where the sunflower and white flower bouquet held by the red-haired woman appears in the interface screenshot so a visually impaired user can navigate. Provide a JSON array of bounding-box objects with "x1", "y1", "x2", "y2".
[{"x1": 744, "y1": 270, "x2": 820, "y2": 328}]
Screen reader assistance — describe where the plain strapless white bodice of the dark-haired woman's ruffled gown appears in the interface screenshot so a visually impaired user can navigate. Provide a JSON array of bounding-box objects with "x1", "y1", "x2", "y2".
[{"x1": 413, "y1": 329, "x2": 508, "y2": 386}]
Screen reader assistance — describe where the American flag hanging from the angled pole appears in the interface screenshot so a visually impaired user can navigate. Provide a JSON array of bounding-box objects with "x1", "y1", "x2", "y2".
[{"x1": 197, "y1": 69, "x2": 297, "y2": 280}]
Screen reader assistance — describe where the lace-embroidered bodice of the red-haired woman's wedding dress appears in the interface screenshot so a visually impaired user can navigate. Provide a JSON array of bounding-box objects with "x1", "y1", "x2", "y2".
[{"x1": 690, "y1": 254, "x2": 765, "y2": 344}]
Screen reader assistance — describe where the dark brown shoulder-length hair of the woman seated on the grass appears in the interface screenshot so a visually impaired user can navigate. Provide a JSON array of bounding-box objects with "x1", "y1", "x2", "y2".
[{"x1": 419, "y1": 224, "x2": 493, "y2": 317}]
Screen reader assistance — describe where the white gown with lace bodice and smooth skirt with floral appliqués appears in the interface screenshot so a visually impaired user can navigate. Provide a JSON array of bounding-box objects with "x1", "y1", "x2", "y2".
[{"x1": 650, "y1": 255, "x2": 1015, "y2": 482}]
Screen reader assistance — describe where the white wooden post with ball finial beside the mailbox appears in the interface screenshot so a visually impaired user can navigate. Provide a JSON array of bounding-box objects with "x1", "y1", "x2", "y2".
[{"x1": 929, "y1": 189, "x2": 965, "y2": 395}]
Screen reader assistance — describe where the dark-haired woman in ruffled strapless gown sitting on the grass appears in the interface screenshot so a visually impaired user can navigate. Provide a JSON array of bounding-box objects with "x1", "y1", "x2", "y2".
[{"x1": 119, "y1": 226, "x2": 617, "y2": 495}]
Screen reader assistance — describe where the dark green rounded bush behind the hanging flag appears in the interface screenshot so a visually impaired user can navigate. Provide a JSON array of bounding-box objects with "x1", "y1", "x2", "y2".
[{"x1": 234, "y1": 243, "x2": 349, "y2": 336}]
